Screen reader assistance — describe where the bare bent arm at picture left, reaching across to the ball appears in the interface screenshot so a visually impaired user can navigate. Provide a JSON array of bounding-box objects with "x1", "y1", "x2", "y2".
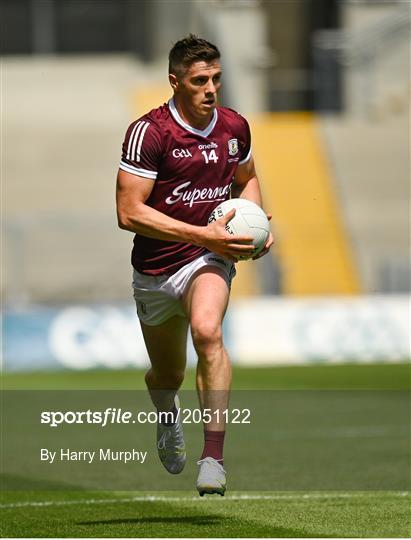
[{"x1": 116, "y1": 169, "x2": 254, "y2": 261}]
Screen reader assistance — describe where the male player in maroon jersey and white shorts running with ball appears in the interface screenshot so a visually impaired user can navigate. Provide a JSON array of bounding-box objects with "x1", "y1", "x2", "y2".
[{"x1": 117, "y1": 35, "x2": 273, "y2": 495}]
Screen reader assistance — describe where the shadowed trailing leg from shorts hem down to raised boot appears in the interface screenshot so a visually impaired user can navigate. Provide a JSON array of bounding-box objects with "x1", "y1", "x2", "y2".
[{"x1": 141, "y1": 316, "x2": 188, "y2": 474}]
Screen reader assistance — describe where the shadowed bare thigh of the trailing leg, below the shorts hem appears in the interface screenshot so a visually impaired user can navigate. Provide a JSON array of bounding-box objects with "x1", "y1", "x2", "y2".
[{"x1": 140, "y1": 316, "x2": 188, "y2": 380}]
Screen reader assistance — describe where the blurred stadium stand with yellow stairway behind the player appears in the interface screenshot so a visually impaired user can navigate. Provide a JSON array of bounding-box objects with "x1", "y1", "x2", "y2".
[{"x1": 0, "y1": 0, "x2": 410, "y2": 304}]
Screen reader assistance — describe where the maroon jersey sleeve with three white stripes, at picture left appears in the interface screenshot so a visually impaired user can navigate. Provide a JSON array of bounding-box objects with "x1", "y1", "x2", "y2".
[{"x1": 120, "y1": 119, "x2": 162, "y2": 180}]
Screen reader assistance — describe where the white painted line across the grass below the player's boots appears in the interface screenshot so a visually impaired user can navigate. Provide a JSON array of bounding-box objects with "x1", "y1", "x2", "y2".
[{"x1": 0, "y1": 491, "x2": 409, "y2": 509}]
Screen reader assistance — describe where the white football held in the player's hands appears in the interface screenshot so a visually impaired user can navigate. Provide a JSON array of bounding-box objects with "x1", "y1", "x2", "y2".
[{"x1": 208, "y1": 199, "x2": 270, "y2": 260}]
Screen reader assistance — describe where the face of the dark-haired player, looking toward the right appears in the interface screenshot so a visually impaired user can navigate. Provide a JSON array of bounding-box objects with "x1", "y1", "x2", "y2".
[{"x1": 173, "y1": 60, "x2": 221, "y2": 119}]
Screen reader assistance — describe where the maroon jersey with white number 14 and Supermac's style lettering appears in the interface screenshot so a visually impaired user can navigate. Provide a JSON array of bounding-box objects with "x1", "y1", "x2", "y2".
[{"x1": 120, "y1": 99, "x2": 251, "y2": 276}]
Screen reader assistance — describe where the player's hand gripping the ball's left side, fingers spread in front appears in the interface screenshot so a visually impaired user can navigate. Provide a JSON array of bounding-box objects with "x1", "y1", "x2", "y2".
[{"x1": 202, "y1": 208, "x2": 255, "y2": 262}]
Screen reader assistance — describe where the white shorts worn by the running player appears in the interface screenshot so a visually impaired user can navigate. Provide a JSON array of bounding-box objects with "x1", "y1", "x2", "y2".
[{"x1": 133, "y1": 253, "x2": 236, "y2": 326}]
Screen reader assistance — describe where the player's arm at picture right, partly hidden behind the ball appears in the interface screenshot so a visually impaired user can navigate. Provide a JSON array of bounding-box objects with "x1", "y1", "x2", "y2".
[{"x1": 231, "y1": 156, "x2": 274, "y2": 259}]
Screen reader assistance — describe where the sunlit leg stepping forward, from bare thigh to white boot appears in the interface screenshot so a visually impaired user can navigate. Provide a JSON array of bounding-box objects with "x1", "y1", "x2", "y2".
[{"x1": 184, "y1": 266, "x2": 231, "y2": 495}]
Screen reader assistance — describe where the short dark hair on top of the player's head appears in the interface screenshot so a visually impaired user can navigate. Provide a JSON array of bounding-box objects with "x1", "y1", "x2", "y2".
[{"x1": 168, "y1": 34, "x2": 220, "y2": 75}]
